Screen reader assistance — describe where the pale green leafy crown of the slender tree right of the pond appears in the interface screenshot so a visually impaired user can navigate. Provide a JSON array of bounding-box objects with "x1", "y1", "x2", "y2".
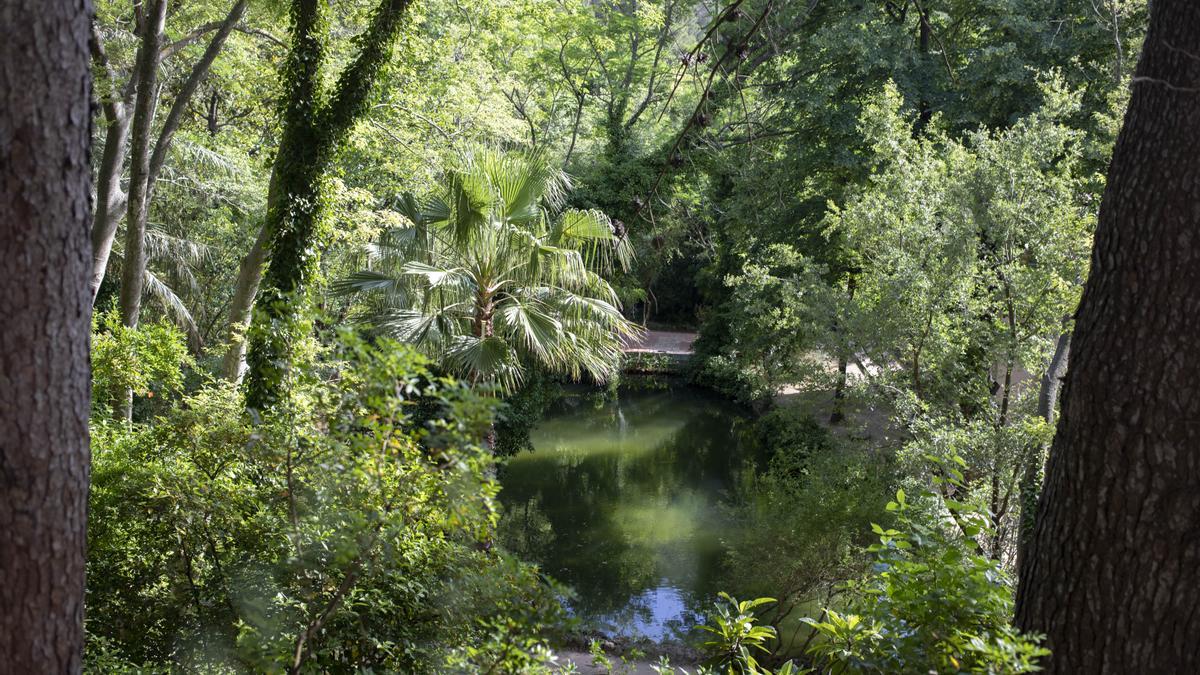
[{"x1": 828, "y1": 79, "x2": 1094, "y2": 410}]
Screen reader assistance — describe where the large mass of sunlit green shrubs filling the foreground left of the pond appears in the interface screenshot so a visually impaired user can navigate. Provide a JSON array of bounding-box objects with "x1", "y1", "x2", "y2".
[{"x1": 88, "y1": 334, "x2": 560, "y2": 671}]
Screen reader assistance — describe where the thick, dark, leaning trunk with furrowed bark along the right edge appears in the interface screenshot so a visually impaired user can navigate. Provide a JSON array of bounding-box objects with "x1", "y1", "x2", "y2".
[{"x1": 1016, "y1": 5, "x2": 1200, "y2": 674}]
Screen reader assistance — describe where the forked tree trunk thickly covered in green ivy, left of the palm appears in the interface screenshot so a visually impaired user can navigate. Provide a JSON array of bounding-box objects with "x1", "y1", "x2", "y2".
[{"x1": 246, "y1": 0, "x2": 409, "y2": 410}]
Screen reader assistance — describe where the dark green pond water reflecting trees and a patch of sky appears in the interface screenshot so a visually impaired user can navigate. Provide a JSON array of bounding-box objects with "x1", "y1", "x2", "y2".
[{"x1": 500, "y1": 387, "x2": 757, "y2": 640}]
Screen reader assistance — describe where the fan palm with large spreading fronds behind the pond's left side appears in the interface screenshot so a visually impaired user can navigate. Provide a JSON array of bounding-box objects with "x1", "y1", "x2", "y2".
[{"x1": 336, "y1": 149, "x2": 638, "y2": 394}]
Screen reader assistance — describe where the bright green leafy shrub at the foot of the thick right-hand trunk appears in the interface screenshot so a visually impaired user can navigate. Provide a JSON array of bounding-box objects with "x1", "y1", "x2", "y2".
[{"x1": 805, "y1": 490, "x2": 1049, "y2": 674}]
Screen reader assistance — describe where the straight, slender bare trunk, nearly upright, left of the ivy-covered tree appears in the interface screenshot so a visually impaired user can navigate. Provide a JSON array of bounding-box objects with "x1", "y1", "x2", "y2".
[{"x1": 121, "y1": 0, "x2": 167, "y2": 329}]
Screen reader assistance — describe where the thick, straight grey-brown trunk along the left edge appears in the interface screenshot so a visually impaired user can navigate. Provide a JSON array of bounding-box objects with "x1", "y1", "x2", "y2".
[{"x1": 0, "y1": 0, "x2": 91, "y2": 674}]
